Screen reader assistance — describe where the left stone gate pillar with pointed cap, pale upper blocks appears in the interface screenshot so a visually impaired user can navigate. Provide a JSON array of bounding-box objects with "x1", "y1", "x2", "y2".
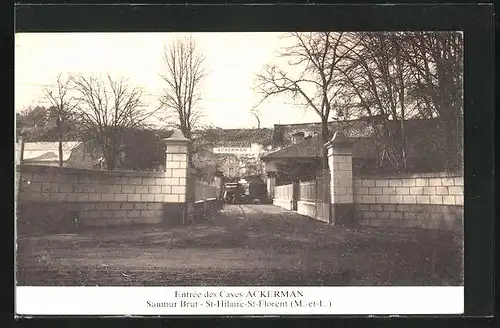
[{"x1": 164, "y1": 130, "x2": 190, "y2": 223}]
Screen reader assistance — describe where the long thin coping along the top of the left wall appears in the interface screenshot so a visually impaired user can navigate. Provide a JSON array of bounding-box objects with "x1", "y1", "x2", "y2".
[{"x1": 16, "y1": 165, "x2": 165, "y2": 178}]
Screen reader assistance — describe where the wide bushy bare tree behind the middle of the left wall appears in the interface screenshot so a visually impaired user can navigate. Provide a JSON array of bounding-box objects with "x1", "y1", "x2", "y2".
[{"x1": 74, "y1": 74, "x2": 156, "y2": 170}]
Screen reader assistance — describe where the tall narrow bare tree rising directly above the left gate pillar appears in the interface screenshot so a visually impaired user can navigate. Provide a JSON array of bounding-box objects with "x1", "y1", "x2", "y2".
[{"x1": 160, "y1": 38, "x2": 206, "y2": 143}]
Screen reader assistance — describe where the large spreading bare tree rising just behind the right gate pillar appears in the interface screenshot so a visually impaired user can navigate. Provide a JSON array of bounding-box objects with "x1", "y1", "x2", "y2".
[{"x1": 256, "y1": 32, "x2": 354, "y2": 164}]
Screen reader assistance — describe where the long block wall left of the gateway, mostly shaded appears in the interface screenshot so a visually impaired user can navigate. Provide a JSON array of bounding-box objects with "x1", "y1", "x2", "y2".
[{"x1": 17, "y1": 167, "x2": 186, "y2": 233}]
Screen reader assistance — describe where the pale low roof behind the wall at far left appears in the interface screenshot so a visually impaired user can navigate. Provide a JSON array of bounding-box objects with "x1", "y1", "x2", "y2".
[{"x1": 23, "y1": 141, "x2": 80, "y2": 162}]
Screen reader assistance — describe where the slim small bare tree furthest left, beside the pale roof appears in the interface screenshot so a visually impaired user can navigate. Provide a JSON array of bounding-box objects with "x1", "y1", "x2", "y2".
[{"x1": 44, "y1": 74, "x2": 78, "y2": 166}]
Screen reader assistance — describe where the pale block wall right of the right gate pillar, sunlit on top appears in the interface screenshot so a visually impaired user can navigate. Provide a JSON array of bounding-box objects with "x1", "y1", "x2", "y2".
[{"x1": 353, "y1": 173, "x2": 464, "y2": 230}]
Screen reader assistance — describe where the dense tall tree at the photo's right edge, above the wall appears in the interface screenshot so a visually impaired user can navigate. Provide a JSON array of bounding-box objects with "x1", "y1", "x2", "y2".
[{"x1": 402, "y1": 31, "x2": 463, "y2": 170}]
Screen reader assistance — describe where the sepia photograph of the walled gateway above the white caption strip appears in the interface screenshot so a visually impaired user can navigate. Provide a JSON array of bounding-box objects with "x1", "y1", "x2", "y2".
[{"x1": 14, "y1": 30, "x2": 464, "y2": 311}]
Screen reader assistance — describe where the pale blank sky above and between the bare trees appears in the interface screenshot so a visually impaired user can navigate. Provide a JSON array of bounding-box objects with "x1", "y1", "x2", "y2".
[{"x1": 14, "y1": 32, "x2": 319, "y2": 128}]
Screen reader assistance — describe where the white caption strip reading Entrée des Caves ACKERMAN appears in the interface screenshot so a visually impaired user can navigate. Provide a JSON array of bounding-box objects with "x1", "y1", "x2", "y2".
[{"x1": 15, "y1": 287, "x2": 464, "y2": 316}]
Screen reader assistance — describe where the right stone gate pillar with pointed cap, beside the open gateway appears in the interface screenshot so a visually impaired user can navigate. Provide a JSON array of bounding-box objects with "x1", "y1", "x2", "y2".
[{"x1": 325, "y1": 132, "x2": 354, "y2": 224}]
